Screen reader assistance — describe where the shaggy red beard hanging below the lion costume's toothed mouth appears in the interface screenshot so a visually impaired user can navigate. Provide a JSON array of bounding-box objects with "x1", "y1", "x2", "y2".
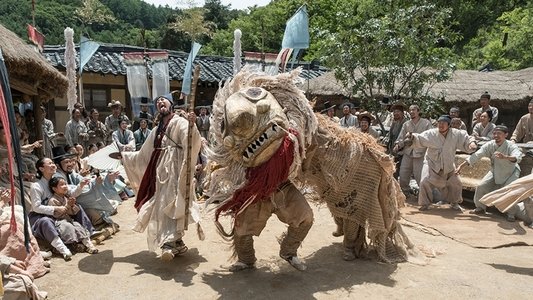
[{"x1": 215, "y1": 129, "x2": 298, "y2": 221}]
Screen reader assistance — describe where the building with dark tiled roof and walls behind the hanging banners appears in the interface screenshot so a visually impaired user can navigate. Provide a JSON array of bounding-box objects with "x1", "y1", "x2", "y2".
[{"x1": 44, "y1": 43, "x2": 325, "y2": 128}]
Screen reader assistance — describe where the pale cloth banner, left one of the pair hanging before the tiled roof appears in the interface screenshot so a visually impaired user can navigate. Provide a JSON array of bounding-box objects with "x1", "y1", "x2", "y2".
[{"x1": 123, "y1": 53, "x2": 151, "y2": 116}]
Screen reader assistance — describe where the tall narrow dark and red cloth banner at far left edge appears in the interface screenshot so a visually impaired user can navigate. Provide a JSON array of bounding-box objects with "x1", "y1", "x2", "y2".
[{"x1": 0, "y1": 49, "x2": 30, "y2": 252}]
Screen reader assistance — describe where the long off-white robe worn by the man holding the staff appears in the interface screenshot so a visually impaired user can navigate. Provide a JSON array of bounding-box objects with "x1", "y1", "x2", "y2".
[{"x1": 122, "y1": 115, "x2": 201, "y2": 252}]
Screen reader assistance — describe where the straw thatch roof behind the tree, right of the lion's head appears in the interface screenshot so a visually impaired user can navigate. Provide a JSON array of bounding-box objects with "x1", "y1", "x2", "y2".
[{"x1": 306, "y1": 68, "x2": 533, "y2": 102}]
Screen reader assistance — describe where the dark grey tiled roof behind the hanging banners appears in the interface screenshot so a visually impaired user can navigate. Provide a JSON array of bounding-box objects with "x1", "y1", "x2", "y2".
[{"x1": 43, "y1": 44, "x2": 327, "y2": 82}]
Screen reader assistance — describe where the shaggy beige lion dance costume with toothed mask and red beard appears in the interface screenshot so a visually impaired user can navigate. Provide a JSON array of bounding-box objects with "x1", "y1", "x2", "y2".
[{"x1": 208, "y1": 69, "x2": 412, "y2": 271}]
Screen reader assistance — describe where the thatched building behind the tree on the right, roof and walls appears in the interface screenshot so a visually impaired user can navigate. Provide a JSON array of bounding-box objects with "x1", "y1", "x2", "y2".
[{"x1": 304, "y1": 68, "x2": 533, "y2": 130}]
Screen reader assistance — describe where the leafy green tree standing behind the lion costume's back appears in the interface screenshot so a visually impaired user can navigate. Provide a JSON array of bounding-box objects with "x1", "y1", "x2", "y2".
[{"x1": 317, "y1": 0, "x2": 459, "y2": 116}]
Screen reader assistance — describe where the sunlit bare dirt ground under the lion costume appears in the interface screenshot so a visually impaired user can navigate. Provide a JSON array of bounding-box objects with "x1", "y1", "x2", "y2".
[{"x1": 36, "y1": 200, "x2": 533, "y2": 299}]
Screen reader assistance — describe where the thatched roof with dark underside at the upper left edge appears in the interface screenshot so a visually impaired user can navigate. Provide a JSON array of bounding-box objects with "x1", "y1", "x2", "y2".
[{"x1": 0, "y1": 24, "x2": 68, "y2": 97}]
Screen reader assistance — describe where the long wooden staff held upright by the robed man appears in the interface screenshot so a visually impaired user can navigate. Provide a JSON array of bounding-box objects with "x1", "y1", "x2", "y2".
[{"x1": 184, "y1": 65, "x2": 200, "y2": 230}]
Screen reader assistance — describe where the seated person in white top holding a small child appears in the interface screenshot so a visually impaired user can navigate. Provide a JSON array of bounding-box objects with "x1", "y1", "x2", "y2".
[{"x1": 28, "y1": 157, "x2": 93, "y2": 260}]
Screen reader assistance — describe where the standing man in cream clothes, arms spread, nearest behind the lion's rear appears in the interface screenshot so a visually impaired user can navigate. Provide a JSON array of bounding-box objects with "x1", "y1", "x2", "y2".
[{"x1": 405, "y1": 115, "x2": 477, "y2": 211}]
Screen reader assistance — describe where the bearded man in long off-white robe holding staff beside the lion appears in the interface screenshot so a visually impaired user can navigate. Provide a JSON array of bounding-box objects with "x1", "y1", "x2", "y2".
[{"x1": 122, "y1": 94, "x2": 200, "y2": 260}]
